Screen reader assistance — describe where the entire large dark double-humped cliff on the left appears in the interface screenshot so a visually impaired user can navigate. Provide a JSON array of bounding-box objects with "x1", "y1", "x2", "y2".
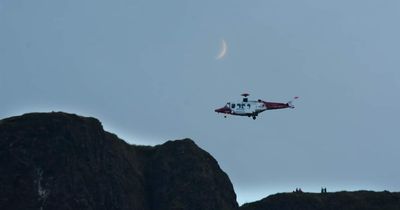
[{"x1": 0, "y1": 113, "x2": 237, "y2": 210}]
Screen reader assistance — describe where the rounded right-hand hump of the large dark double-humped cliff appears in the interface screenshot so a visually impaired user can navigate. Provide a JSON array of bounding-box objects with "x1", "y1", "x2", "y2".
[{"x1": 147, "y1": 140, "x2": 237, "y2": 210}]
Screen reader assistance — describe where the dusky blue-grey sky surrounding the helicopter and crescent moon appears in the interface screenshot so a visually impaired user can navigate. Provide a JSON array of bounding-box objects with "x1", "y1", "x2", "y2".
[{"x1": 0, "y1": 0, "x2": 400, "y2": 204}]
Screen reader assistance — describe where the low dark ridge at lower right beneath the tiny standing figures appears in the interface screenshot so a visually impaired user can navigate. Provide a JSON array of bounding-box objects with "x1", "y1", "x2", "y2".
[{"x1": 240, "y1": 191, "x2": 400, "y2": 210}]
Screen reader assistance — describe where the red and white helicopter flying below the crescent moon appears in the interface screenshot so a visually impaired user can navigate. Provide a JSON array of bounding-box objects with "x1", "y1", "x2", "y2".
[{"x1": 215, "y1": 93, "x2": 299, "y2": 120}]
